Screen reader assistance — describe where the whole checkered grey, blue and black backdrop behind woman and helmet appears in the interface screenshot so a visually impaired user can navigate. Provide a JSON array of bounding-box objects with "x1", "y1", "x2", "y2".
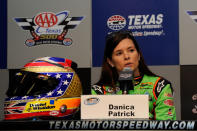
[{"x1": 0, "y1": 0, "x2": 197, "y2": 120}]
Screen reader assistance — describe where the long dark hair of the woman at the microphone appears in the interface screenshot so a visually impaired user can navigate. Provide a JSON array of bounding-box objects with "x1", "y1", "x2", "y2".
[{"x1": 96, "y1": 30, "x2": 156, "y2": 87}]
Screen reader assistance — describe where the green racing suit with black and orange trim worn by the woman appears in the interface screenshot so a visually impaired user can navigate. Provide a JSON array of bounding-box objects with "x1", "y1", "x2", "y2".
[{"x1": 91, "y1": 75, "x2": 176, "y2": 120}]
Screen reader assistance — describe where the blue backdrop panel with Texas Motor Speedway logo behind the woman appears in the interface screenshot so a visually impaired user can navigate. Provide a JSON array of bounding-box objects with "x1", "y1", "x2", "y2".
[{"x1": 92, "y1": 0, "x2": 179, "y2": 67}]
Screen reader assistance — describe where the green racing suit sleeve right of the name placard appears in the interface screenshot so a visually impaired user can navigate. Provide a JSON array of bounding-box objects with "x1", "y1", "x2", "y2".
[{"x1": 154, "y1": 79, "x2": 176, "y2": 120}]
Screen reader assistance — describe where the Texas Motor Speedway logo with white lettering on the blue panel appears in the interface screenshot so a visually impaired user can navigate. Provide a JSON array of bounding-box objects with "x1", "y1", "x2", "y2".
[{"x1": 107, "y1": 13, "x2": 165, "y2": 36}]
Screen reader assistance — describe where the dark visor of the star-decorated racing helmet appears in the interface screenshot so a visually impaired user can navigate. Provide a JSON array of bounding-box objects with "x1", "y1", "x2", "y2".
[{"x1": 6, "y1": 71, "x2": 59, "y2": 97}]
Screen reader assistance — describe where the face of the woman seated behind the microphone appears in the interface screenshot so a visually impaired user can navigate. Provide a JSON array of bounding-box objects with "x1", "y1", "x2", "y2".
[{"x1": 108, "y1": 38, "x2": 140, "y2": 76}]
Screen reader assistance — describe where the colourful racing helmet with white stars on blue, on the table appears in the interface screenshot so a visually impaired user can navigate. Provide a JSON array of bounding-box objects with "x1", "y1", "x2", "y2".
[{"x1": 4, "y1": 57, "x2": 82, "y2": 120}]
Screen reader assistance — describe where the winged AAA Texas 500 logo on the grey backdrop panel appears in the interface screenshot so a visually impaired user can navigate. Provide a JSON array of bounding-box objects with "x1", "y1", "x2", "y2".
[{"x1": 15, "y1": 11, "x2": 84, "y2": 47}]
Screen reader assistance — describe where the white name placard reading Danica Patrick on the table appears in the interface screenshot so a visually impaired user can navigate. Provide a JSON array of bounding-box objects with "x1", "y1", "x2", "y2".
[{"x1": 81, "y1": 95, "x2": 149, "y2": 119}]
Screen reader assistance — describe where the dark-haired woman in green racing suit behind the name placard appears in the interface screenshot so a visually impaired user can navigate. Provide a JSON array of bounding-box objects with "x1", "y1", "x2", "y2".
[{"x1": 91, "y1": 31, "x2": 176, "y2": 120}]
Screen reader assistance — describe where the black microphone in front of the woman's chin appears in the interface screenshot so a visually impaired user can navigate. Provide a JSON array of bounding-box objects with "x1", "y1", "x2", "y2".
[{"x1": 118, "y1": 67, "x2": 133, "y2": 94}]
